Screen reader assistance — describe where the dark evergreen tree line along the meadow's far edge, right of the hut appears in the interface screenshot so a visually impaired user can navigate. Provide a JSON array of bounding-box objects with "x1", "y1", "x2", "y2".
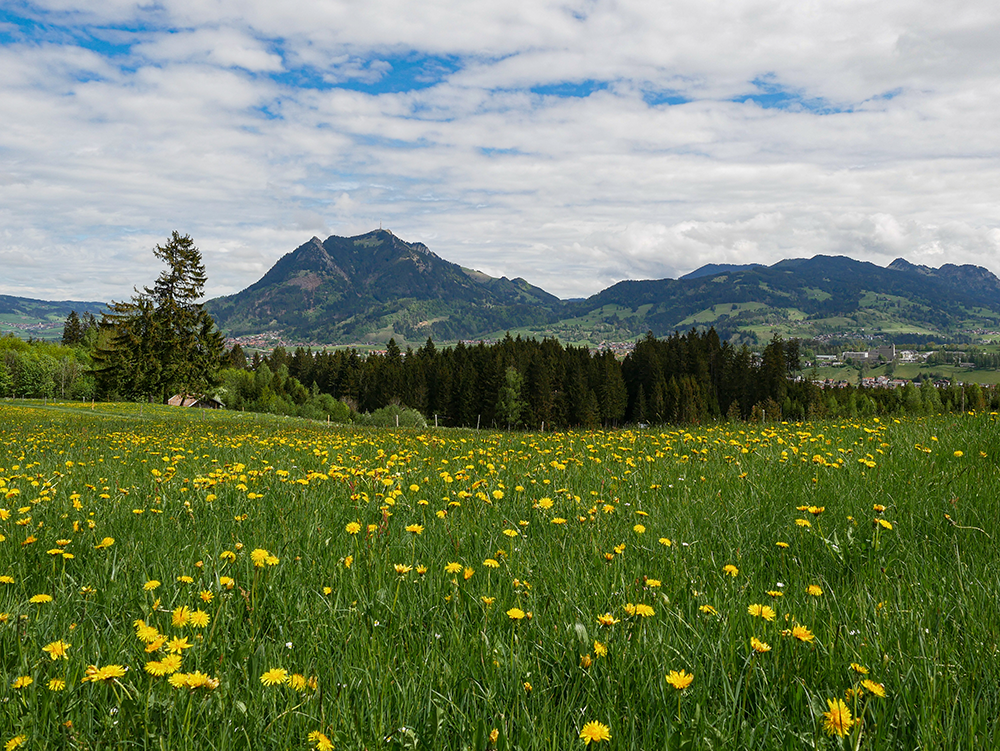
[{"x1": 222, "y1": 329, "x2": 1000, "y2": 430}]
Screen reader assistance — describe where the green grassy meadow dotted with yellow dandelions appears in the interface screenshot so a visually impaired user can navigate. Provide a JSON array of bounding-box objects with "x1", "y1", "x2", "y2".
[{"x1": 0, "y1": 401, "x2": 1000, "y2": 751}]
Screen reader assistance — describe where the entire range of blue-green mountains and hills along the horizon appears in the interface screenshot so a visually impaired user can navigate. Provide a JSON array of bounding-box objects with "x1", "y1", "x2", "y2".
[{"x1": 7, "y1": 229, "x2": 1000, "y2": 345}]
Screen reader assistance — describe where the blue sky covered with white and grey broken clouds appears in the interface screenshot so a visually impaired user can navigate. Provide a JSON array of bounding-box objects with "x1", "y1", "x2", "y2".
[{"x1": 0, "y1": 0, "x2": 1000, "y2": 300}]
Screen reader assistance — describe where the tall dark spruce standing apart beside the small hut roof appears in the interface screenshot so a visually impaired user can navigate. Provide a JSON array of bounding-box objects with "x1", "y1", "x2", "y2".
[{"x1": 94, "y1": 231, "x2": 224, "y2": 402}]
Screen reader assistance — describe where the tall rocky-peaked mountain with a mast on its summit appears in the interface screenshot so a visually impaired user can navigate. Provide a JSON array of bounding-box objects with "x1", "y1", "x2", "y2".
[{"x1": 206, "y1": 230, "x2": 563, "y2": 343}]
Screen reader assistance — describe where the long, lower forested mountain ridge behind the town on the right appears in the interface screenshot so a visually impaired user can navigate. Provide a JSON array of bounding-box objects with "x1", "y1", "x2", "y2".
[{"x1": 570, "y1": 256, "x2": 1000, "y2": 338}]
